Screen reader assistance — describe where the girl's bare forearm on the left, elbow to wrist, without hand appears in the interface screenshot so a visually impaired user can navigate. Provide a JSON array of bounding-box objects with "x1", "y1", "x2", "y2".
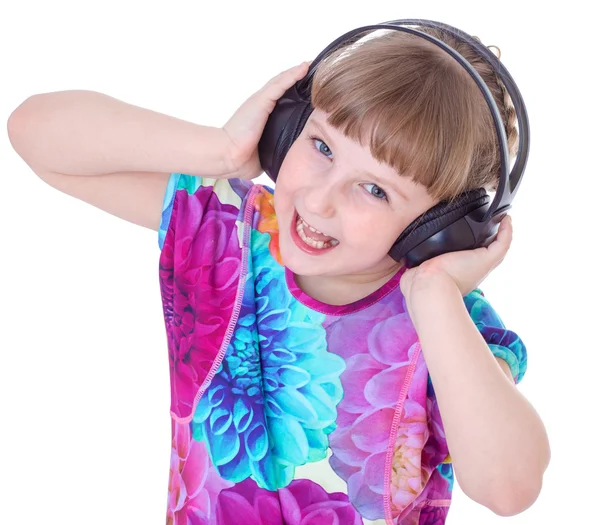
[{"x1": 8, "y1": 90, "x2": 227, "y2": 177}]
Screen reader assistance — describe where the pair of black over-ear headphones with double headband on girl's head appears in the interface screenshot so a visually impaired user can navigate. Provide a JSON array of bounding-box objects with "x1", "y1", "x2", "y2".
[{"x1": 258, "y1": 19, "x2": 529, "y2": 268}]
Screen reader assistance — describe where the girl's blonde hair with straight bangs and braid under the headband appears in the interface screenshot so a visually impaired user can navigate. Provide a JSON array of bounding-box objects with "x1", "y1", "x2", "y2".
[{"x1": 311, "y1": 27, "x2": 518, "y2": 200}]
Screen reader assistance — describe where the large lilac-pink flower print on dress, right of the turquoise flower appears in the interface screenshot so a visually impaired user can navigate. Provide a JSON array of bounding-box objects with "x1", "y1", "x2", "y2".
[{"x1": 327, "y1": 300, "x2": 424, "y2": 520}]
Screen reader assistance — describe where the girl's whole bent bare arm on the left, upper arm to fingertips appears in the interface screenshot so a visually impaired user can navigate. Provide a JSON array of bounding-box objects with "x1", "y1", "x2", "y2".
[{"x1": 7, "y1": 63, "x2": 307, "y2": 230}]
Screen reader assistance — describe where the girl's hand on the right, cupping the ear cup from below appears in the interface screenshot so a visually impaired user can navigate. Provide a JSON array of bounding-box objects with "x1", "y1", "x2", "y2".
[{"x1": 400, "y1": 215, "x2": 512, "y2": 302}]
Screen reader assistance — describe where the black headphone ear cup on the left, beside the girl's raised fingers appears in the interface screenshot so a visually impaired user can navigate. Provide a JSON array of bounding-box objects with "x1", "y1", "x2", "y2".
[{"x1": 258, "y1": 83, "x2": 313, "y2": 182}]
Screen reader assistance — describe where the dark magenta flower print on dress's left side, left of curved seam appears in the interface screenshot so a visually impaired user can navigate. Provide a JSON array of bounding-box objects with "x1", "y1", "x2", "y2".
[{"x1": 160, "y1": 186, "x2": 241, "y2": 418}]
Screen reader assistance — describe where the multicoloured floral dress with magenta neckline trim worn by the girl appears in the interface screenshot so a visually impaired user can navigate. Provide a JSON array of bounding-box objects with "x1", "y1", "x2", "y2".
[{"x1": 159, "y1": 173, "x2": 527, "y2": 525}]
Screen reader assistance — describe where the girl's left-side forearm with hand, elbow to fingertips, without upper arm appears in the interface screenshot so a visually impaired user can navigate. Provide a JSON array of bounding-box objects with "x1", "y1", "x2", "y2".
[{"x1": 8, "y1": 63, "x2": 308, "y2": 179}]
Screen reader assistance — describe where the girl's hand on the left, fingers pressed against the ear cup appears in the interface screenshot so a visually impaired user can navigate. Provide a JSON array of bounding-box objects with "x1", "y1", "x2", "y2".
[{"x1": 223, "y1": 62, "x2": 310, "y2": 179}]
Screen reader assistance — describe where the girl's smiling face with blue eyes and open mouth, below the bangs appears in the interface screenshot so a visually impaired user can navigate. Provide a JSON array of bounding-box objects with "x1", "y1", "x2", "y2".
[{"x1": 275, "y1": 109, "x2": 436, "y2": 280}]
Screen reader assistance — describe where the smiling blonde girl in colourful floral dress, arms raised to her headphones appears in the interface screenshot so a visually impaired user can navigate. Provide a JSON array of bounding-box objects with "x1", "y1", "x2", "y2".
[{"x1": 8, "y1": 22, "x2": 550, "y2": 525}]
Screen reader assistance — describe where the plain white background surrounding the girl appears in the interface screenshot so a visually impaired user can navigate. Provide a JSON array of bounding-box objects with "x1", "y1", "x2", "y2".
[{"x1": 0, "y1": 0, "x2": 600, "y2": 525}]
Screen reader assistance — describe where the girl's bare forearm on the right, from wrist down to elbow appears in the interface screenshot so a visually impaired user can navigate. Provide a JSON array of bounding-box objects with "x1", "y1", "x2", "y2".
[{"x1": 409, "y1": 279, "x2": 549, "y2": 514}]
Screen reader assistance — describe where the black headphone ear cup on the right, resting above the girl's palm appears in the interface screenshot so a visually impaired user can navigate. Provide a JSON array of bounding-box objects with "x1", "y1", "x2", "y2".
[{"x1": 389, "y1": 188, "x2": 490, "y2": 268}]
